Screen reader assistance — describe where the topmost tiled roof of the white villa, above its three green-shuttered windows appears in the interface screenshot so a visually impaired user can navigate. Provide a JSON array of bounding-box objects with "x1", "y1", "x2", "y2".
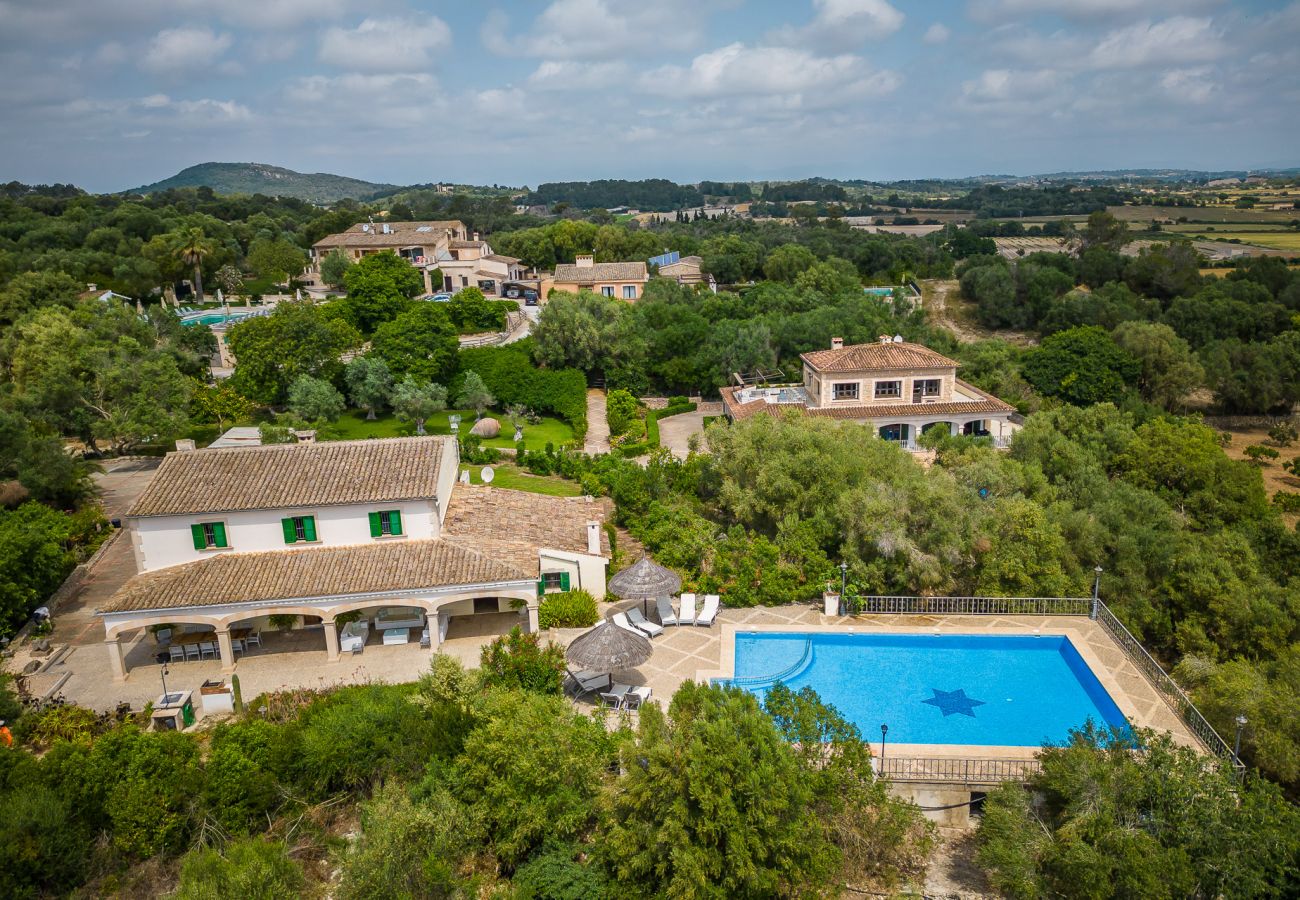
[{"x1": 126, "y1": 436, "x2": 451, "y2": 516}]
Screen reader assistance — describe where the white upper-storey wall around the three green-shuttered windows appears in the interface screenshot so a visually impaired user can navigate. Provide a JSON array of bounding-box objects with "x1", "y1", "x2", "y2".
[{"x1": 127, "y1": 499, "x2": 441, "y2": 572}]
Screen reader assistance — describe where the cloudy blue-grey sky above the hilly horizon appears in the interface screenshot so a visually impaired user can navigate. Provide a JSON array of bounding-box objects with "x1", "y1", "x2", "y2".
[{"x1": 0, "y1": 0, "x2": 1300, "y2": 191}]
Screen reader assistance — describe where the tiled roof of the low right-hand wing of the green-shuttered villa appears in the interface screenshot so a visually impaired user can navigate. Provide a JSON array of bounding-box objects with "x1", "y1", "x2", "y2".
[{"x1": 442, "y1": 484, "x2": 610, "y2": 568}]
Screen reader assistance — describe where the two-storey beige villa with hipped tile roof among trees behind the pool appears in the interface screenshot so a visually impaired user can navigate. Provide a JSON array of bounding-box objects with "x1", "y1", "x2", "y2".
[{"x1": 722, "y1": 336, "x2": 1019, "y2": 450}]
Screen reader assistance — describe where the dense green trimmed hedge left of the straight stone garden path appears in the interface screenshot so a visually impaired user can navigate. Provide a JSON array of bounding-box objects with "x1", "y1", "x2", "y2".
[{"x1": 452, "y1": 340, "x2": 586, "y2": 441}]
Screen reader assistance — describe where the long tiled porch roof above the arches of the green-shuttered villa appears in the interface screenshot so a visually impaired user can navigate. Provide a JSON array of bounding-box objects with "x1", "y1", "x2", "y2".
[{"x1": 99, "y1": 540, "x2": 537, "y2": 613}]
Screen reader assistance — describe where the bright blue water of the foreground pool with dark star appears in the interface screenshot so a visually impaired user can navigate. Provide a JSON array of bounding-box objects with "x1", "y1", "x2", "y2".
[{"x1": 732, "y1": 632, "x2": 1127, "y2": 747}]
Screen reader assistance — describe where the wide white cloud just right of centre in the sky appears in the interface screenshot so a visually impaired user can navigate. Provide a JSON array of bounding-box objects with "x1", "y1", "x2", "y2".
[{"x1": 641, "y1": 43, "x2": 901, "y2": 107}]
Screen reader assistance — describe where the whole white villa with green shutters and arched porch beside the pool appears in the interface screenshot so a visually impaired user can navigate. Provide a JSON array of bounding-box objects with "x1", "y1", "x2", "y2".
[{"x1": 98, "y1": 436, "x2": 610, "y2": 679}]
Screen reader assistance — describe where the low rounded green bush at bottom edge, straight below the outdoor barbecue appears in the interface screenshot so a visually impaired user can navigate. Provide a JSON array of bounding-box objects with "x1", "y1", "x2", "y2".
[{"x1": 172, "y1": 838, "x2": 306, "y2": 900}]
